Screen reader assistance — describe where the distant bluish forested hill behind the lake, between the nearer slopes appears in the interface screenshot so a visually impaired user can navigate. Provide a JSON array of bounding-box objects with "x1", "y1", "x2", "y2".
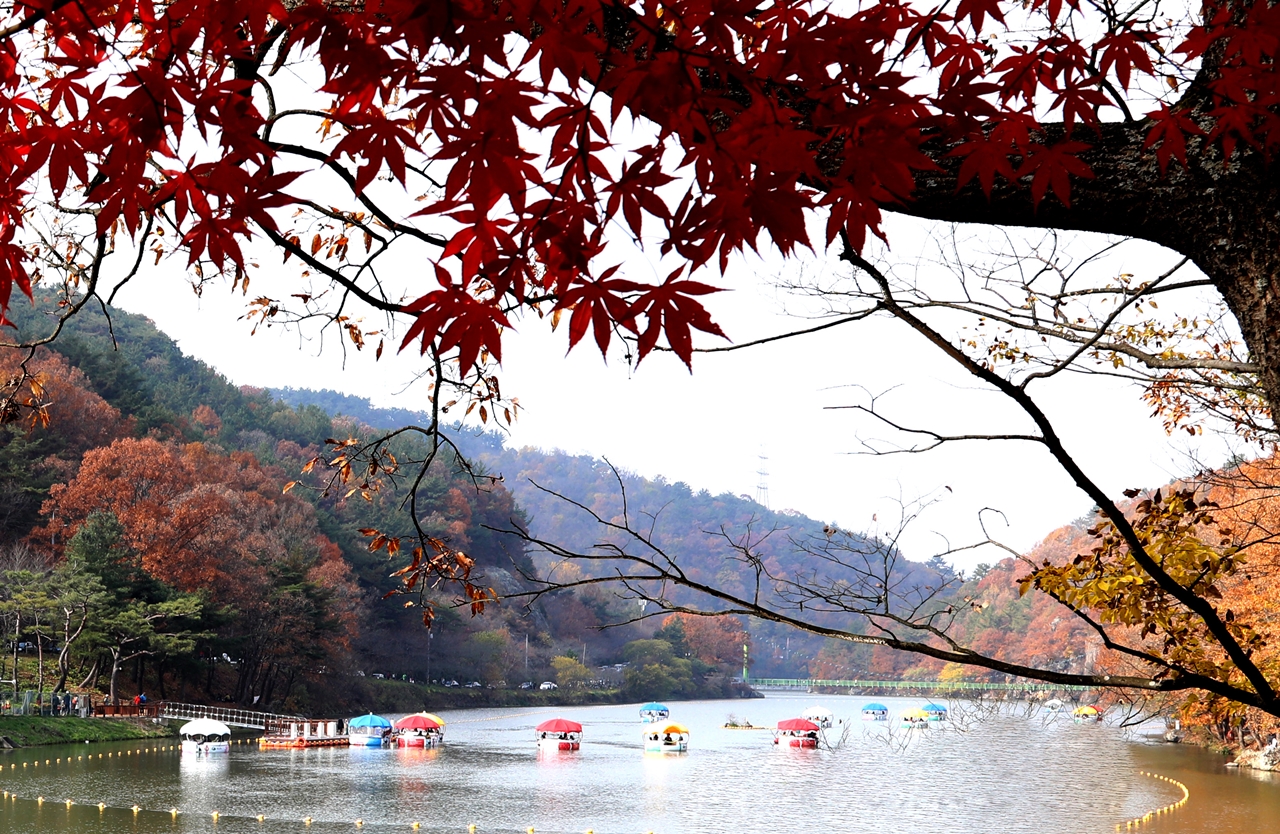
[{"x1": 264, "y1": 389, "x2": 952, "y2": 677}]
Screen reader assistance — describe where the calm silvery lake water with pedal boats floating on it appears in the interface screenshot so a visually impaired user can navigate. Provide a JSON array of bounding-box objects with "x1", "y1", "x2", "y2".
[{"x1": 0, "y1": 696, "x2": 1280, "y2": 834}]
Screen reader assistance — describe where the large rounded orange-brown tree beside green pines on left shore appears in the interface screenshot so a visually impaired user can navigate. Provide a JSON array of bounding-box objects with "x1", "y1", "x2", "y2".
[{"x1": 36, "y1": 439, "x2": 360, "y2": 704}]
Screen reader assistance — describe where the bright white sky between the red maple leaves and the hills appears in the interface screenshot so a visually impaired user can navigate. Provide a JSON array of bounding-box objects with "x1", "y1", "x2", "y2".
[{"x1": 107, "y1": 212, "x2": 1228, "y2": 568}]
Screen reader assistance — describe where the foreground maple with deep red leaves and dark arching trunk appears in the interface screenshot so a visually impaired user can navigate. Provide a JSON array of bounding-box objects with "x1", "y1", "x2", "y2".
[{"x1": 0, "y1": 0, "x2": 1280, "y2": 710}]
